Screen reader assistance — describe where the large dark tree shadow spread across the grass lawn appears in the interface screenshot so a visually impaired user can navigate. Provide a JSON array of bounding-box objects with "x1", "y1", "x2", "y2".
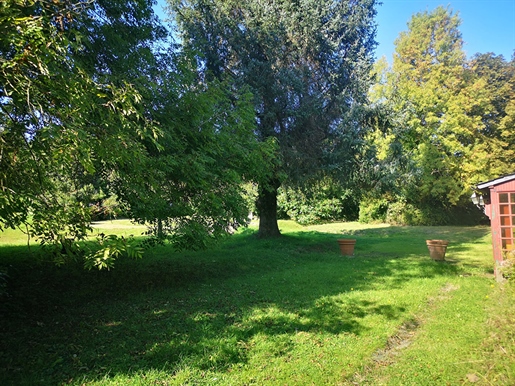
[{"x1": 0, "y1": 228, "x2": 492, "y2": 385}]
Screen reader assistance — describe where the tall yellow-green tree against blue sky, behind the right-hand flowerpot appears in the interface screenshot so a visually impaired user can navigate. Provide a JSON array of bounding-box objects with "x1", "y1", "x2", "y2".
[{"x1": 389, "y1": 7, "x2": 470, "y2": 205}]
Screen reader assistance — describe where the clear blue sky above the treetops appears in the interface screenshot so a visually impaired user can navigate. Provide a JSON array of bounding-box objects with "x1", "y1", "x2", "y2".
[{"x1": 155, "y1": 0, "x2": 515, "y2": 62}]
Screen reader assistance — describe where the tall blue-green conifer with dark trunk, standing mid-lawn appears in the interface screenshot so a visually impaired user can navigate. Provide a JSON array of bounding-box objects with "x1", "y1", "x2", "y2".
[{"x1": 169, "y1": 0, "x2": 375, "y2": 237}]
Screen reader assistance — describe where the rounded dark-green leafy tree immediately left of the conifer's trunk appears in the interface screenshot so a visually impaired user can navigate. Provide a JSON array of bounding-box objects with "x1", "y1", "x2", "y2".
[{"x1": 121, "y1": 55, "x2": 275, "y2": 249}]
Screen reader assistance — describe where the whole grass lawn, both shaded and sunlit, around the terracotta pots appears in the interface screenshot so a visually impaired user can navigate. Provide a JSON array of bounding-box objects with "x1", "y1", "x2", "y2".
[{"x1": 0, "y1": 221, "x2": 515, "y2": 386}]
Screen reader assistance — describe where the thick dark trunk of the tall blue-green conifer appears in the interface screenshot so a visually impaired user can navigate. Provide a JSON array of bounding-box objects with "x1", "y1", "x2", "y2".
[{"x1": 256, "y1": 181, "x2": 281, "y2": 239}]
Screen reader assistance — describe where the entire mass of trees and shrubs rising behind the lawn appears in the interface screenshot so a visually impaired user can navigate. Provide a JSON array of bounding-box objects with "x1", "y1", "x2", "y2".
[{"x1": 0, "y1": 0, "x2": 515, "y2": 267}]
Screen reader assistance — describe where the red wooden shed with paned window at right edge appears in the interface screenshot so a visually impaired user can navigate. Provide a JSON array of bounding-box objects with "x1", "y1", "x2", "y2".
[{"x1": 477, "y1": 173, "x2": 515, "y2": 279}]
